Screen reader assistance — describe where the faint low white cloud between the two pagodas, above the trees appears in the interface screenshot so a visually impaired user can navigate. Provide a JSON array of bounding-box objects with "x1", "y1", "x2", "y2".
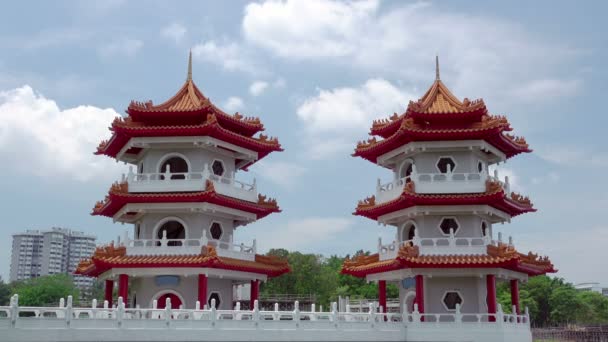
[{"x1": 256, "y1": 217, "x2": 354, "y2": 251}]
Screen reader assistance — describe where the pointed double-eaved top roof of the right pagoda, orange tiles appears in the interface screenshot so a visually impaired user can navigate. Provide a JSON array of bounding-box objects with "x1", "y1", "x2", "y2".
[{"x1": 353, "y1": 60, "x2": 531, "y2": 163}]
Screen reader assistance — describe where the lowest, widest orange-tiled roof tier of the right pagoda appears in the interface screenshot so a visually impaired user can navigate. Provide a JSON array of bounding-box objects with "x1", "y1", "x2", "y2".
[{"x1": 342, "y1": 243, "x2": 557, "y2": 277}]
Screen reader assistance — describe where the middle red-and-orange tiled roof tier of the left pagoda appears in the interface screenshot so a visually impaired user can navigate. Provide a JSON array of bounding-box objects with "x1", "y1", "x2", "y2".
[{"x1": 91, "y1": 181, "x2": 281, "y2": 219}]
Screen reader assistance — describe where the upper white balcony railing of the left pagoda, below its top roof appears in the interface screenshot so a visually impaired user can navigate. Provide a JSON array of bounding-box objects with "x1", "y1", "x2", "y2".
[{"x1": 123, "y1": 164, "x2": 258, "y2": 202}]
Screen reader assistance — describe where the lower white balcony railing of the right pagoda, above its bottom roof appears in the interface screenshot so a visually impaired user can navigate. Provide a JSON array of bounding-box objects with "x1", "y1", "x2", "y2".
[{"x1": 378, "y1": 231, "x2": 513, "y2": 260}]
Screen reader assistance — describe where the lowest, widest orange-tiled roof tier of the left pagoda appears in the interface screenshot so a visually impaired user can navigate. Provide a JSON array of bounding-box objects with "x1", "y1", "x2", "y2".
[{"x1": 75, "y1": 245, "x2": 290, "y2": 277}]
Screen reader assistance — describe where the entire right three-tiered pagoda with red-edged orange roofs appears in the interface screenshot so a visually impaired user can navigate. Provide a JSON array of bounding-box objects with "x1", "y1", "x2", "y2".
[{"x1": 342, "y1": 60, "x2": 556, "y2": 322}]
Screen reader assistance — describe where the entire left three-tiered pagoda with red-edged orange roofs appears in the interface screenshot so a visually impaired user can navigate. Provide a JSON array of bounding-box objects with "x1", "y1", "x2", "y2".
[{"x1": 76, "y1": 53, "x2": 289, "y2": 309}]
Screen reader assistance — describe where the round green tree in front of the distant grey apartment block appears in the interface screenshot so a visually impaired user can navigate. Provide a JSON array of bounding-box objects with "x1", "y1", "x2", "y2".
[{"x1": 12, "y1": 274, "x2": 79, "y2": 306}]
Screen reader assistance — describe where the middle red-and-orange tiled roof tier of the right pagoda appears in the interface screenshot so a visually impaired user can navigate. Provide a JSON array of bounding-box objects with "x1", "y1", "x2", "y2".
[{"x1": 353, "y1": 181, "x2": 536, "y2": 220}]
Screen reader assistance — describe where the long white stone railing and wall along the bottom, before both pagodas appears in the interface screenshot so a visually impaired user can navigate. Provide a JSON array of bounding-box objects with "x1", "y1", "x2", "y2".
[{"x1": 0, "y1": 295, "x2": 531, "y2": 342}]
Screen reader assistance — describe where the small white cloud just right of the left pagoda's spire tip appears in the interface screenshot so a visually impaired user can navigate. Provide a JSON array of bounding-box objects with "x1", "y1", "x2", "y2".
[{"x1": 192, "y1": 40, "x2": 260, "y2": 74}]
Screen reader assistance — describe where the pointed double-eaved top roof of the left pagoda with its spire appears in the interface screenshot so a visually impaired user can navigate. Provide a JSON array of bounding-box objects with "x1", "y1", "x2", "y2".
[{"x1": 96, "y1": 55, "x2": 283, "y2": 167}]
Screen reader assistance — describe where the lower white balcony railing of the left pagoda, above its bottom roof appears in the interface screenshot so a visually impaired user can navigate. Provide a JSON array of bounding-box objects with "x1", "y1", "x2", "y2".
[{"x1": 124, "y1": 231, "x2": 257, "y2": 261}]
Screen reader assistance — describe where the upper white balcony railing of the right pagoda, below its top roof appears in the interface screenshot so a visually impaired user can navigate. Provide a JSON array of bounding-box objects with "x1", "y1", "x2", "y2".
[{"x1": 376, "y1": 167, "x2": 510, "y2": 203}]
